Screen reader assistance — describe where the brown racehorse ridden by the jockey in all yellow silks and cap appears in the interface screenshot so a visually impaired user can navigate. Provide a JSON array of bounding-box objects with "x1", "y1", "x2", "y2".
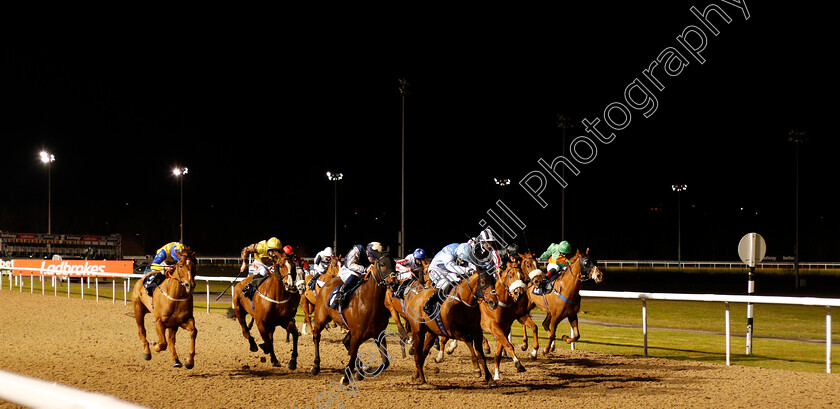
[{"x1": 233, "y1": 254, "x2": 300, "y2": 370}]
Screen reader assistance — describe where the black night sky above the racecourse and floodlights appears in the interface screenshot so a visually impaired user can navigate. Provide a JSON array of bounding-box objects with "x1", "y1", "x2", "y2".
[{"x1": 0, "y1": 1, "x2": 840, "y2": 261}]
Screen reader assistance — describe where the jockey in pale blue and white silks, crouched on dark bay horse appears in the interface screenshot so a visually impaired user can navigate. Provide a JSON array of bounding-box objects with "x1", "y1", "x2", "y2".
[{"x1": 423, "y1": 243, "x2": 479, "y2": 317}]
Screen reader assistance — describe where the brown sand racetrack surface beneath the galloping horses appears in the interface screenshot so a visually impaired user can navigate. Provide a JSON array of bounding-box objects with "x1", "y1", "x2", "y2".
[{"x1": 0, "y1": 289, "x2": 840, "y2": 409}]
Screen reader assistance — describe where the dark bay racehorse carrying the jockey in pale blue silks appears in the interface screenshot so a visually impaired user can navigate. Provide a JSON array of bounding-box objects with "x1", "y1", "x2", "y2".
[{"x1": 406, "y1": 269, "x2": 498, "y2": 387}]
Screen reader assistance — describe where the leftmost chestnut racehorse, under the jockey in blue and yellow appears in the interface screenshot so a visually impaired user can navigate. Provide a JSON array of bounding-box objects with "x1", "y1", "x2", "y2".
[{"x1": 131, "y1": 247, "x2": 198, "y2": 369}]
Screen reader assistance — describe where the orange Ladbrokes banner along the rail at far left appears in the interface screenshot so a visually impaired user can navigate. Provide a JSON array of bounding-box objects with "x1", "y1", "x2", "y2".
[{"x1": 12, "y1": 259, "x2": 134, "y2": 277}]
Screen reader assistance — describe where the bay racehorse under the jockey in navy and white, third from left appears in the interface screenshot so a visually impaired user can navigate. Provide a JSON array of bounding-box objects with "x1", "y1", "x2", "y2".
[{"x1": 310, "y1": 249, "x2": 402, "y2": 385}]
